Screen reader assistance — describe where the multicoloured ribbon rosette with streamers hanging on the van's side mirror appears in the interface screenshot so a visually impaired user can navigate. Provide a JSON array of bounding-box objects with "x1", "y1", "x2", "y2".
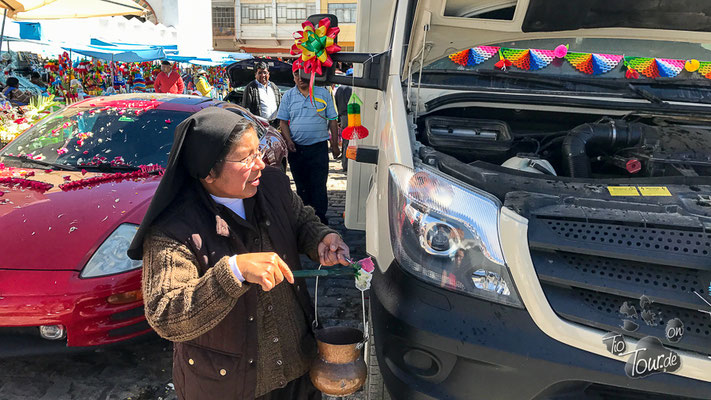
[{"x1": 291, "y1": 18, "x2": 341, "y2": 102}]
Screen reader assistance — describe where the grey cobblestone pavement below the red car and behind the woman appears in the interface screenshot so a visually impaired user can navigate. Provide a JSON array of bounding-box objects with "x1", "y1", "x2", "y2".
[{"x1": 0, "y1": 161, "x2": 365, "y2": 400}]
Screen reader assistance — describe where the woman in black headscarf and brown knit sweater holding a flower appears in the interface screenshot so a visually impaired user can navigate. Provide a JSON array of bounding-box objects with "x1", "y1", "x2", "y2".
[{"x1": 128, "y1": 107, "x2": 350, "y2": 400}]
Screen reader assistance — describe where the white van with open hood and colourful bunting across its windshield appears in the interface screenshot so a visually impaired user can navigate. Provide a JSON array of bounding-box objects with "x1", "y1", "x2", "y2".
[{"x1": 332, "y1": 0, "x2": 711, "y2": 400}]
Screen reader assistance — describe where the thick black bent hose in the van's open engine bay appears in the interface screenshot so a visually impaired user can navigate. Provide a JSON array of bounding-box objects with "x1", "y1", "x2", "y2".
[{"x1": 562, "y1": 121, "x2": 654, "y2": 178}]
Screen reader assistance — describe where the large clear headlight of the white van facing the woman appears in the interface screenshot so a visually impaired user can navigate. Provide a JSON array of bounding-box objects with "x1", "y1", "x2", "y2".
[{"x1": 389, "y1": 165, "x2": 523, "y2": 308}]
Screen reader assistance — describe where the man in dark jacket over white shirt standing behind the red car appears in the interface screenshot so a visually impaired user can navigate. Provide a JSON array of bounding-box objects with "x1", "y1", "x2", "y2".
[{"x1": 242, "y1": 62, "x2": 281, "y2": 122}]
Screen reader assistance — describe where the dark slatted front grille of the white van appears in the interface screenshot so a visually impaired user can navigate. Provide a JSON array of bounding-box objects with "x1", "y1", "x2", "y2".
[{"x1": 529, "y1": 216, "x2": 711, "y2": 354}]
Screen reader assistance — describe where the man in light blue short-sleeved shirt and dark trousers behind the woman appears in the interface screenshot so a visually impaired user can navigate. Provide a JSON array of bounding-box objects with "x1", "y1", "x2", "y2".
[{"x1": 277, "y1": 71, "x2": 341, "y2": 224}]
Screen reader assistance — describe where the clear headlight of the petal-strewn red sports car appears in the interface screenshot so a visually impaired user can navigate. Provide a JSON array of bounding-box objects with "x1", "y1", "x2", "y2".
[{"x1": 80, "y1": 224, "x2": 143, "y2": 278}]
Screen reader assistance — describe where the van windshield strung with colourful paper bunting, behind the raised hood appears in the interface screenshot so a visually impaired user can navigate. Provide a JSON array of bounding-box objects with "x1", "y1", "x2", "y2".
[{"x1": 422, "y1": 38, "x2": 711, "y2": 103}]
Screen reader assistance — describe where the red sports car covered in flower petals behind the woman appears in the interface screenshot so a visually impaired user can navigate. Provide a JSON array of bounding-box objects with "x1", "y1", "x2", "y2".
[{"x1": 0, "y1": 94, "x2": 287, "y2": 356}]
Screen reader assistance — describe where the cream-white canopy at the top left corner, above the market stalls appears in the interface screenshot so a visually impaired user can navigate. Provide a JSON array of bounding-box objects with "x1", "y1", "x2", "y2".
[{"x1": 0, "y1": 0, "x2": 149, "y2": 21}]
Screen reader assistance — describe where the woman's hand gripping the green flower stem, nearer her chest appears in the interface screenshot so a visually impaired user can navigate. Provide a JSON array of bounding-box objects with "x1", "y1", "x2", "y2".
[{"x1": 235, "y1": 253, "x2": 294, "y2": 292}]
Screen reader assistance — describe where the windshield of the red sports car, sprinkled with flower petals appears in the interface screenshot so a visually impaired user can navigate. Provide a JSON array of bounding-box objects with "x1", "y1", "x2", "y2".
[{"x1": 0, "y1": 102, "x2": 190, "y2": 168}]
